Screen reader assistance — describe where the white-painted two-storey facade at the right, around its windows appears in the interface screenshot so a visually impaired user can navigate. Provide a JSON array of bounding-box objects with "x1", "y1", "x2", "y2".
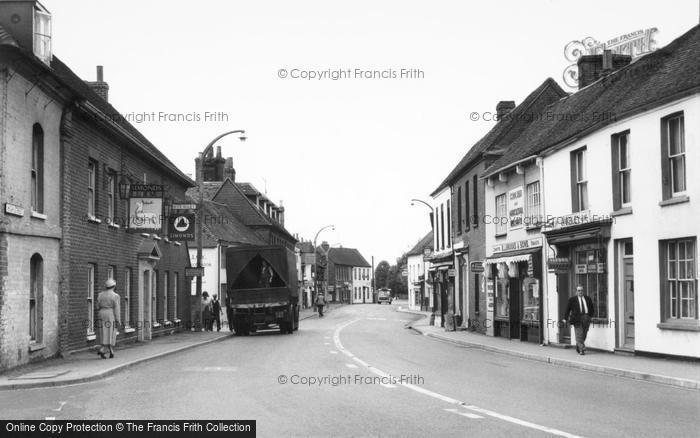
[{"x1": 540, "y1": 94, "x2": 700, "y2": 358}]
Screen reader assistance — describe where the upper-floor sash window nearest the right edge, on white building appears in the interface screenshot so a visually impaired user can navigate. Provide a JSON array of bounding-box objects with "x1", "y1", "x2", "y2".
[{"x1": 661, "y1": 112, "x2": 686, "y2": 199}]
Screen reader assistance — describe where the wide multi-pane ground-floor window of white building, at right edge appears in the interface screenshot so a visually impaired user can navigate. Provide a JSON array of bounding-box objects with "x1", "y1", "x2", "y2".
[{"x1": 661, "y1": 238, "x2": 698, "y2": 321}]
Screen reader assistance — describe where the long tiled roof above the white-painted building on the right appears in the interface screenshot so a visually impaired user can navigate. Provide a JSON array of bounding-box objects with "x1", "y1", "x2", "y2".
[{"x1": 483, "y1": 25, "x2": 700, "y2": 176}]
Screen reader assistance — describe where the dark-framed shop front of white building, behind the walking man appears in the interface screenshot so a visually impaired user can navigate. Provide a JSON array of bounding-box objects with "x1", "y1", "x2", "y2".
[{"x1": 544, "y1": 222, "x2": 610, "y2": 346}]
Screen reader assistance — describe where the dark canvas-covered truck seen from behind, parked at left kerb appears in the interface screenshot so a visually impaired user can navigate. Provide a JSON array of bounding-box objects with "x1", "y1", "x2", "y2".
[{"x1": 226, "y1": 245, "x2": 299, "y2": 336}]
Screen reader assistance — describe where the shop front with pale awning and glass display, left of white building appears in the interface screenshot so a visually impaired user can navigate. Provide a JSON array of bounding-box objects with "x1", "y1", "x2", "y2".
[{"x1": 484, "y1": 238, "x2": 543, "y2": 343}]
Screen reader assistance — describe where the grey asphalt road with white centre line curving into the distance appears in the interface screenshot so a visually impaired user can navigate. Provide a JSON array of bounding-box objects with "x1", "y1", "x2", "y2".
[{"x1": 0, "y1": 304, "x2": 700, "y2": 438}]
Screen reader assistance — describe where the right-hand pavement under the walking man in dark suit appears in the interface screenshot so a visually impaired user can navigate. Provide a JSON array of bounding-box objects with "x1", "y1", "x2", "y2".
[{"x1": 397, "y1": 306, "x2": 700, "y2": 390}]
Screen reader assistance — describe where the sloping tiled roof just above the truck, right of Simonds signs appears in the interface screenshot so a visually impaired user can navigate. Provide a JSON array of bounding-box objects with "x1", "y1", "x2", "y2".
[{"x1": 202, "y1": 201, "x2": 267, "y2": 248}]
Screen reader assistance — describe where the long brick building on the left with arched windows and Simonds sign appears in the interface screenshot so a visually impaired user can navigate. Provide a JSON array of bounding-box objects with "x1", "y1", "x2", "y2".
[{"x1": 0, "y1": 0, "x2": 194, "y2": 366}]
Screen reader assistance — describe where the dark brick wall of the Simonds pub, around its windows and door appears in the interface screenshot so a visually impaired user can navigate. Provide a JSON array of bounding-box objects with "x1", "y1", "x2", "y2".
[{"x1": 61, "y1": 111, "x2": 190, "y2": 350}]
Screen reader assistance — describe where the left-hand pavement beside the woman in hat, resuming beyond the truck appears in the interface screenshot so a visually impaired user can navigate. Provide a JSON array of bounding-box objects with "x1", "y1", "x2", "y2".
[{"x1": 0, "y1": 303, "x2": 341, "y2": 391}]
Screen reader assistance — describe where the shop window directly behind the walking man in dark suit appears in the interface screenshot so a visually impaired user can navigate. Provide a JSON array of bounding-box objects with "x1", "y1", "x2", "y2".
[{"x1": 571, "y1": 249, "x2": 608, "y2": 319}]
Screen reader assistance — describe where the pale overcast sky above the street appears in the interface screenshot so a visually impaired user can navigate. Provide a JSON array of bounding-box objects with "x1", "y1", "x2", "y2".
[{"x1": 42, "y1": 0, "x2": 699, "y2": 264}]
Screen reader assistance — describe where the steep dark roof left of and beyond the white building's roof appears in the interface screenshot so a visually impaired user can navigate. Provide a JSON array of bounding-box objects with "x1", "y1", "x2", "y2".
[{"x1": 430, "y1": 78, "x2": 568, "y2": 196}]
